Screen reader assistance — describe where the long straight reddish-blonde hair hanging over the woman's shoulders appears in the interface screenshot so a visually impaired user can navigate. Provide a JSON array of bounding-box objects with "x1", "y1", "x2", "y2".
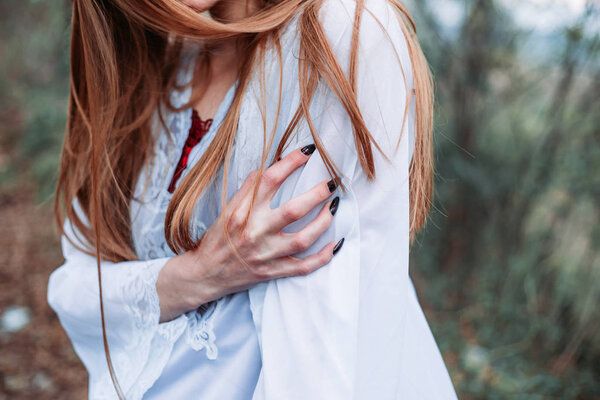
[{"x1": 55, "y1": 0, "x2": 434, "y2": 399}]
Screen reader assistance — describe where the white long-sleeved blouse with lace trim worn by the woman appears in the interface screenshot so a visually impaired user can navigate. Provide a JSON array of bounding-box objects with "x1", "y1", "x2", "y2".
[{"x1": 48, "y1": 0, "x2": 456, "y2": 400}]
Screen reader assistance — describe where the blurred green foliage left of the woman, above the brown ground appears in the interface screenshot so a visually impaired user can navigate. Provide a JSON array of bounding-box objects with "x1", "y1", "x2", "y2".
[{"x1": 0, "y1": 0, "x2": 70, "y2": 200}]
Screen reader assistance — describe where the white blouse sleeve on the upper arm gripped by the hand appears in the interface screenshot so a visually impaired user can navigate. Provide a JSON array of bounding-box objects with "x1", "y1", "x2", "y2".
[{"x1": 250, "y1": 0, "x2": 414, "y2": 400}]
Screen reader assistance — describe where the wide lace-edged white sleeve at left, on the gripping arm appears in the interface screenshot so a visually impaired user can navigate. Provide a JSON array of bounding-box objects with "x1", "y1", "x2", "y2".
[{"x1": 48, "y1": 202, "x2": 186, "y2": 400}]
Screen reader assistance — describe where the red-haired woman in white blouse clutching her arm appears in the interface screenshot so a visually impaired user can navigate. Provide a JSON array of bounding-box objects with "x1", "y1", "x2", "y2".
[{"x1": 48, "y1": 0, "x2": 455, "y2": 400}]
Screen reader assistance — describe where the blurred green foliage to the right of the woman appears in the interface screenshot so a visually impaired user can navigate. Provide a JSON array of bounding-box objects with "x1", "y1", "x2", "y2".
[{"x1": 411, "y1": 0, "x2": 600, "y2": 399}]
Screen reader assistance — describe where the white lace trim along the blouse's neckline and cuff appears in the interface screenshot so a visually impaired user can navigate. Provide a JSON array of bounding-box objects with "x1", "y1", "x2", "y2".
[{"x1": 124, "y1": 43, "x2": 232, "y2": 366}]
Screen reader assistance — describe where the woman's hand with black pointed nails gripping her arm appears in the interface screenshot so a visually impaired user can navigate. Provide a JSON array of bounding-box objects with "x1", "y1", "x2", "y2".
[{"x1": 156, "y1": 145, "x2": 343, "y2": 322}]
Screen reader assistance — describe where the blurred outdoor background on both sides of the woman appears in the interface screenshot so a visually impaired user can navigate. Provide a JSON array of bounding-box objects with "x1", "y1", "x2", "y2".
[{"x1": 0, "y1": 0, "x2": 600, "y2": 399}]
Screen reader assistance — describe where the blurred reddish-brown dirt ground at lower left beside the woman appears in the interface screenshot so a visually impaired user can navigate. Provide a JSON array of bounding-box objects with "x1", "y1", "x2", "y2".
[{"x1": 0, "y1": 189, "x2": 87, "y2": 400}]
